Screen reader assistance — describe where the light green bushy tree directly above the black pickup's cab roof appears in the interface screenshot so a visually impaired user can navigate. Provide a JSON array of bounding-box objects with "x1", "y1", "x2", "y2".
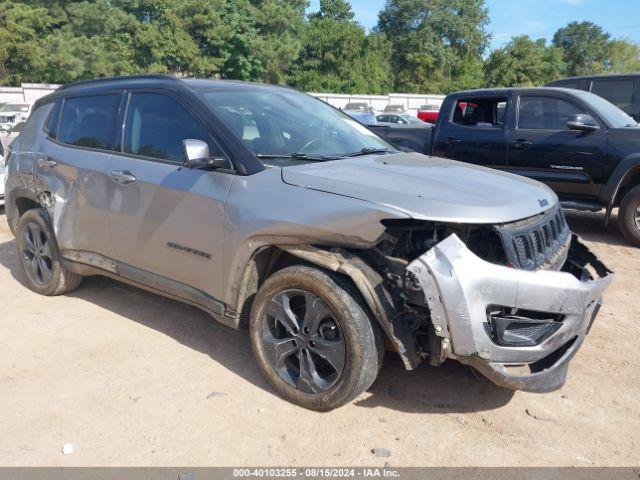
[{"x1": 484, "y1": 35, "x2": 564, "y2": 87}]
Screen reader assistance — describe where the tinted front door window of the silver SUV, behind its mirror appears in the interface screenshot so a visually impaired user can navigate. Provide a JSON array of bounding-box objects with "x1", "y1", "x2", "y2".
[{"x1": 124, "y1": 93, "x2": 220, "y2": 163}]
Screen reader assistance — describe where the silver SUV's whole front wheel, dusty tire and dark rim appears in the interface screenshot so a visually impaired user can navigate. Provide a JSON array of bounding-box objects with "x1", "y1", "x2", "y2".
[{"x1": 249, "y1": 265, "x2": 384, "y2": 411}]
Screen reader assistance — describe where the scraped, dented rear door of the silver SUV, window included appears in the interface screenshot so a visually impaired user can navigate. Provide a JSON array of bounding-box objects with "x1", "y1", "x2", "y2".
[{"x1": 35, "y1": 92, "x2": 122, "y2": 258}]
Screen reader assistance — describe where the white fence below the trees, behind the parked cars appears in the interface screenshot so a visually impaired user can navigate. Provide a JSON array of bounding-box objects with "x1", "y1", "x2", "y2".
[{"x1": 0, "y1": 83, "x2": 444, "y2": 115}]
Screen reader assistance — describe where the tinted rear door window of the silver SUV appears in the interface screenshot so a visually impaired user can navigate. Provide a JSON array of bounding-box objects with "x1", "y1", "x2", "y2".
[{"x1": 58, "y1": 94, "x2": 120, "y2": 150}]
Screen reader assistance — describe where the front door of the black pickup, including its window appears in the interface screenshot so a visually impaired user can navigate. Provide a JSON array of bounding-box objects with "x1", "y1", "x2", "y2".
[{"x1": 508, "y1": 93, "x2": 606, "y2": 197}]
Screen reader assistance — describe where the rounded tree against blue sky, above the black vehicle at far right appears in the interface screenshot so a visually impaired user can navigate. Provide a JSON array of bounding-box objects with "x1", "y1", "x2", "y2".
[{"x1": 553, "y1": 22, "x2": 611, "y2": 76}]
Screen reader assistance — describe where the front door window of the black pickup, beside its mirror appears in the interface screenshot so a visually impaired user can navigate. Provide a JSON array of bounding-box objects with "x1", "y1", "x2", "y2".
[{"x1": 518, "y1": 96, "x2": 586, "y2": 130}]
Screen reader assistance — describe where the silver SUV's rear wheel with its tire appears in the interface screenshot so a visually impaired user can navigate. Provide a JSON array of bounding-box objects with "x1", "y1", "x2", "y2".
[{"x1": 16, "y1": 208, "x2": 82, "y2": 296}]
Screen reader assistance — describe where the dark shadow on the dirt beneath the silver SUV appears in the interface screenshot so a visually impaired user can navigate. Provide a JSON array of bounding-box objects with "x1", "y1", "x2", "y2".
[{"x1": 0, "y1": 241, "x2": 513, "y2": 413}]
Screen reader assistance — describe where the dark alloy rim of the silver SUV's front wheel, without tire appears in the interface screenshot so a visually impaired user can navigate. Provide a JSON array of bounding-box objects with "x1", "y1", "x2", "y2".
[{"x1": 261, "y1": 290, "x2": 347, "y2": 393}]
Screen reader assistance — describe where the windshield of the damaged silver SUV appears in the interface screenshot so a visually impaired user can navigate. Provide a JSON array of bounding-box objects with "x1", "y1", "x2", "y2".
[{"x1": 201, "y1": 88, "x2": 394, "y2": 161}]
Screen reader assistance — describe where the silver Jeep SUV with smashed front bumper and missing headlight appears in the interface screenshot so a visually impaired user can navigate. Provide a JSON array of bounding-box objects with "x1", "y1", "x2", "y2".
[{"x1": 6, "y1": 75, "x2": 612, "y2": 410}]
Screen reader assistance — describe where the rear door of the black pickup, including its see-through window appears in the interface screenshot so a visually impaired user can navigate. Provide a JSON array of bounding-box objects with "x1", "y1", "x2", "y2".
[{"x1": 433, "y1": 97, "x2": 508, "y2": 168}]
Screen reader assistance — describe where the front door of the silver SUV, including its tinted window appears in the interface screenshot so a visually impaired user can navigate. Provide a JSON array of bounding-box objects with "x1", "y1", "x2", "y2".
[{"x1": 109, "y1": 91, "x2": 235, "y2": 298}]
